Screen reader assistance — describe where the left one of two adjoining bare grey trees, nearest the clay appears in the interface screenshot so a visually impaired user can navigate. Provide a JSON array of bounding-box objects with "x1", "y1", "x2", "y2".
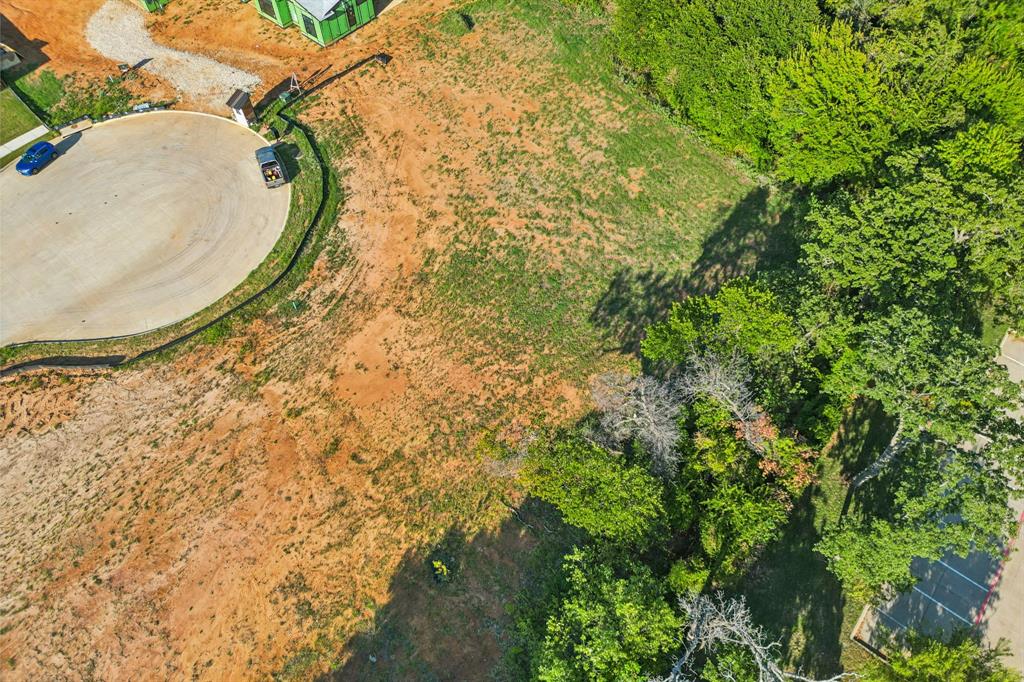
[{"x1": 591, "y1": 372, "x2": 682, "y2": 477}]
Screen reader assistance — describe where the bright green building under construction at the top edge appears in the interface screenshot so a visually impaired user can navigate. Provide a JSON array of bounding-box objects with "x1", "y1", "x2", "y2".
[{"x1": 253, "y1": 0, "x2": 375, "y2": 45}]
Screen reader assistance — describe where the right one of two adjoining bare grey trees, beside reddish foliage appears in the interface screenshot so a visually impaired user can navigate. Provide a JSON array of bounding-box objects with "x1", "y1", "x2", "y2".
[{"x1": 675, "y1": 352, "x2": 767, "y2": 454}]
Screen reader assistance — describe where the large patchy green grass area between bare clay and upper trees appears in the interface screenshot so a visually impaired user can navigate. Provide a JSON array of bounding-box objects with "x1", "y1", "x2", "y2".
[{"x1": 411, "y1": 0, "x2": 773, "y2": 378}]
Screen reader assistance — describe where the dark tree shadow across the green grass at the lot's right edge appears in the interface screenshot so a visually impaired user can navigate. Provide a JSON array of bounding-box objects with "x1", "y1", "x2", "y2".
[{"x1": 590, "y1": 186, "x2": 800, "y2": 354}]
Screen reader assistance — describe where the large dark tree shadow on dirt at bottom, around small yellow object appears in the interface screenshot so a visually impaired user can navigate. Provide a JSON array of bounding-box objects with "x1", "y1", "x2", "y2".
[{"x1": 317, "y1": 501, "x2": 577, "y2": 682}]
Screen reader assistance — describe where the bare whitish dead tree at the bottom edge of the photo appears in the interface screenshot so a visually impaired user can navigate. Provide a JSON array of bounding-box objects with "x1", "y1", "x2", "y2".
[{"x1": 651, "y1": 592, "x2": 859, "y2": 682}]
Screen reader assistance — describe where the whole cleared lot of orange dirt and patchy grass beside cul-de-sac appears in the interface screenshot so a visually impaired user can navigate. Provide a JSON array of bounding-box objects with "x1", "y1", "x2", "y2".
[{"x1": 0, "y1": 0, "x2": 765, "y2": 680}]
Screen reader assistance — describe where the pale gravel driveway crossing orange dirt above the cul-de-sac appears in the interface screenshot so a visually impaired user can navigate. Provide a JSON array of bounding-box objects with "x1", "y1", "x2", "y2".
[{"x1": 85, "y1": 0, "x2": 260, "y2": 109}]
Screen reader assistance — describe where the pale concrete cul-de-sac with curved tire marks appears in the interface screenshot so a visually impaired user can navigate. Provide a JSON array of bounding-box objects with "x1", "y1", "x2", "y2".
[{"x1": 0, "y1": 112, "x2": 290, "y2": 346}]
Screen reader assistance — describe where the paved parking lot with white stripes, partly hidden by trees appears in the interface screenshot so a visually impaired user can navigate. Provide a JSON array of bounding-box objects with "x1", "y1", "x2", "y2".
[{"x1": 853, "y1": 335, "x2": 1024, "y2": 671}]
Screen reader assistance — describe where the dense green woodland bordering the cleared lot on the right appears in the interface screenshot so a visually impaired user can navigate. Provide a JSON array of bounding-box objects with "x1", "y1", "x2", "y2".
[{"x1": 505, "y1": 0, "x2": 1024, "y2": 681}]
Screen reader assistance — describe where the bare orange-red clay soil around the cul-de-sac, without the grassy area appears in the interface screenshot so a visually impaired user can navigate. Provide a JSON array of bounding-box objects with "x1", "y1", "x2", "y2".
[{"x1": 0, "y1": 0, "x2": 753, "y2": 680}]
